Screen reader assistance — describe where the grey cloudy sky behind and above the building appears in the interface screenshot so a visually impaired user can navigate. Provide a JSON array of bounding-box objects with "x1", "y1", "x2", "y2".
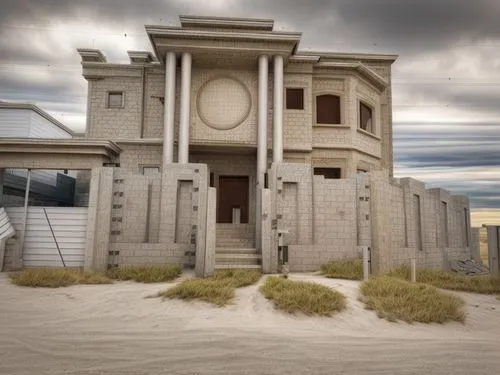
[{"x1": 0, "y1": 0, "x2": 500, "y2": 225}]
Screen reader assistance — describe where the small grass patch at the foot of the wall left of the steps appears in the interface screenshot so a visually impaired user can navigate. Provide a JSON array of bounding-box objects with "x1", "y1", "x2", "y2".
[{"x1": 106, "y1": 265, "x2": 182, "y2": 283}]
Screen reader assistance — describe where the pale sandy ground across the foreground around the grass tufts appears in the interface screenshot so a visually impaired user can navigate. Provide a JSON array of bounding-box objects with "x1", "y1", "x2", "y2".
[{"x1": 0, "y1": 274, "x2": 500, "y2": 375}]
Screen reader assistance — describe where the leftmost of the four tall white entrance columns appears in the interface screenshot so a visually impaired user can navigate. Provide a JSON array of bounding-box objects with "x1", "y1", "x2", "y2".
[{"x1": 163, "y1": 52, "x2": 176, "y2": 164}]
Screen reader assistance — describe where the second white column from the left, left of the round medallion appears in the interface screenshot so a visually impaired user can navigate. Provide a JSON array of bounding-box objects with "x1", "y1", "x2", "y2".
[{"x1": 178, "y1": 52, "x2": 192, "y2": 164}]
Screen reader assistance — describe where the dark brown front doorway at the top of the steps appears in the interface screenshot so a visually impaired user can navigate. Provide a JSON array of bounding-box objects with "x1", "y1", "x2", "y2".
[{"x1": 217, "y1": 176, "x2": 249, "y2": 224}]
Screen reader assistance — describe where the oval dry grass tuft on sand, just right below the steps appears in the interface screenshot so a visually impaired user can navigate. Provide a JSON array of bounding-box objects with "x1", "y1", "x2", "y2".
[{"x1": 260, "y1": 276, "x2": 346, "y2": 316}]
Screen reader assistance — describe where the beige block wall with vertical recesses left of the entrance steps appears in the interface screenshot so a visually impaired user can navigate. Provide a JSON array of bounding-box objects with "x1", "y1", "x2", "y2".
[{"x1": 85, "y1": 164, "x2": 211, "y2": 276}]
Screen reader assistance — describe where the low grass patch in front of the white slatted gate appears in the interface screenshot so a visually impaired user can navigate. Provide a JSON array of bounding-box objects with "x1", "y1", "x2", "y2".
[{"x1": 9, "y1": 268, "x2": 112, "y2": 288}]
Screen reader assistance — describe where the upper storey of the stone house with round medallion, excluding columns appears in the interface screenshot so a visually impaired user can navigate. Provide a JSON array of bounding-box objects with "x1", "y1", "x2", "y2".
[{"x1": 79, "y1": 16, "x2": 396, "y2": 168}]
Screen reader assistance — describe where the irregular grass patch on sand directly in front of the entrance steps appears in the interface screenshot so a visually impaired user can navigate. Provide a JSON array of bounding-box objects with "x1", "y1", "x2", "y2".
[{"x1": 157, "y1": 270, "x2": 261, "y2": 307}]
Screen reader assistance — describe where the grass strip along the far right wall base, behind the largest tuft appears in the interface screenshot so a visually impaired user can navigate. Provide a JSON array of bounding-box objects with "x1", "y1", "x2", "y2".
[{"x1": 387, "y1": 267, "x2": 500, "y2": 294}]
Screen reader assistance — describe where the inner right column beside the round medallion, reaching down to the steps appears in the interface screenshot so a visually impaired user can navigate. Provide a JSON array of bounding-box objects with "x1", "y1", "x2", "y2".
[{"x1": 255, "y1": 55, "x2": 269, "y2": 248}]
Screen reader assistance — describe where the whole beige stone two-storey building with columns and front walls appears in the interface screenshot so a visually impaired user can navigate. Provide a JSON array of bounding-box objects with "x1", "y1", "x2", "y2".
[{"x1": 0, "y1": 16, "x2": 472, "y2": 275}]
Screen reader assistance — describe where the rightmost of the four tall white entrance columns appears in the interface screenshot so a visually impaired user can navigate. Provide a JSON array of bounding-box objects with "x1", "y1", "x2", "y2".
[{"x1": 273, "y1": 56, "x2": 283, "y2": 163}]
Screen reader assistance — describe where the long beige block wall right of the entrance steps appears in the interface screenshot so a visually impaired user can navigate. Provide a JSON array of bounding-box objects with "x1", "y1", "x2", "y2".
[{"x1": 272, "y1": 164, "x2": 476, "y2": 273}]
